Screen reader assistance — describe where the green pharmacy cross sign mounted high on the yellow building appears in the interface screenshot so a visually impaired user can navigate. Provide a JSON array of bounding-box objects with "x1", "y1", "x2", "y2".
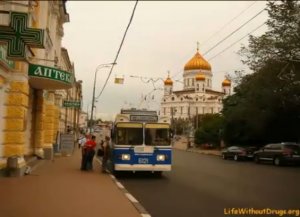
[{"x1": 0, "y1": 12, "x2": 44, "y2": 61}]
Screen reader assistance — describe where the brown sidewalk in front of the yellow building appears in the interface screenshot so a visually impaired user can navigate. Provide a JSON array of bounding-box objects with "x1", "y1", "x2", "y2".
[{"x1": 0, "y1": 150, "x2": 141, "y2": 217}]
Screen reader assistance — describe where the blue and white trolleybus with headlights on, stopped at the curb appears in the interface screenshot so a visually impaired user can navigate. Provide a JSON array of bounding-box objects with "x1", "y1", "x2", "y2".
[{"x1": 110, "y1": 109, "x2": 172, "y2": 175}]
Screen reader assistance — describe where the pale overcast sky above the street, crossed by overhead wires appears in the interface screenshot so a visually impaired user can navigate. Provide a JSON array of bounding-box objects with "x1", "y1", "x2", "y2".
[{"x1": 63, "y1": 1, "x2": 267, "y2": 119}]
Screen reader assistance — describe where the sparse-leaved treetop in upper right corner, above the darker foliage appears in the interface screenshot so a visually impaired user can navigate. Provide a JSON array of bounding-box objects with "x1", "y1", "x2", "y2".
[{"x1": 239, "y1": 0, "x2": 300, "y2": 71}]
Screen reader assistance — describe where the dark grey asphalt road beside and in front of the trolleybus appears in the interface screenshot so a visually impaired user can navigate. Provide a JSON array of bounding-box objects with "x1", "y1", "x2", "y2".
[{"x1": 119, "y1": 150, "x2": 300, "y2": 217}]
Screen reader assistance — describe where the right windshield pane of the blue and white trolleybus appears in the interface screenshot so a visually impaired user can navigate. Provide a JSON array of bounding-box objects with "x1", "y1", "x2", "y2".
[{"x1": 145, "y1": 124, "x2": 170, "y2": 146}]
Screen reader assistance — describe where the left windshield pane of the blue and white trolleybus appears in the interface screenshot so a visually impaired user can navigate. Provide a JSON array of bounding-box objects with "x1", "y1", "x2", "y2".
[{"x1": 116, "y1": 123, "x2": 143, "y2": 145}]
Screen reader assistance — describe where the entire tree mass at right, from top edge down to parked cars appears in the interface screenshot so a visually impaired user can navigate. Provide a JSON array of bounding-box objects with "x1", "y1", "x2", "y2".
[{"x1": 222, "y1": 0, "x2": 300, "y2": 145}]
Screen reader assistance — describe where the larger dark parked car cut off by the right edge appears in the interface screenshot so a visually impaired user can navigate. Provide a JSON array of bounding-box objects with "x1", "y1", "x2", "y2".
[{"x1": 254, "y1": 143, "x2": 300, "y2": 166}]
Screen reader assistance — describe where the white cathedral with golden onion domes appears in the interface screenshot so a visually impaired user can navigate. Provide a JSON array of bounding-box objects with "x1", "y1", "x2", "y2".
[{"x1": 160, "y1": 46, "x2": 231, "y2": 120}]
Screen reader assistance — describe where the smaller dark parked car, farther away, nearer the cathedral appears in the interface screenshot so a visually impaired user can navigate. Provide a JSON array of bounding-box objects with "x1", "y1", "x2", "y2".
[{"x1": 222, "y1": 146, "x2": 257, "y2": 161}]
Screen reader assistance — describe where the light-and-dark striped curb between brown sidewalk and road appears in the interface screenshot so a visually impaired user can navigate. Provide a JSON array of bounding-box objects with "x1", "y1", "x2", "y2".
[{"x1": 96, "y1": 158, "x2": 151, "y2": 217}]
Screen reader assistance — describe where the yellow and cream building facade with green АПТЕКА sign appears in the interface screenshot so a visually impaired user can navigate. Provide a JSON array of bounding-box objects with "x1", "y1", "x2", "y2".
[{"x1": 0, "y1": 1, "x2": 82, "y2": 174}]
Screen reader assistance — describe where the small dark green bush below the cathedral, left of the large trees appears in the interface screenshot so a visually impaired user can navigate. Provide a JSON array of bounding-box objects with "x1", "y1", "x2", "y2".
[{"x1": 195, "y1": 114, "x2": 223, "y2": 146}]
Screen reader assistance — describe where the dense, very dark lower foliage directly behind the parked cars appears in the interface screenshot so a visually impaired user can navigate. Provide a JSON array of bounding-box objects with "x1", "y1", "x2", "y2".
[{"x1": 223, "y1": 61, "x2": 300, "y2": 145}]
